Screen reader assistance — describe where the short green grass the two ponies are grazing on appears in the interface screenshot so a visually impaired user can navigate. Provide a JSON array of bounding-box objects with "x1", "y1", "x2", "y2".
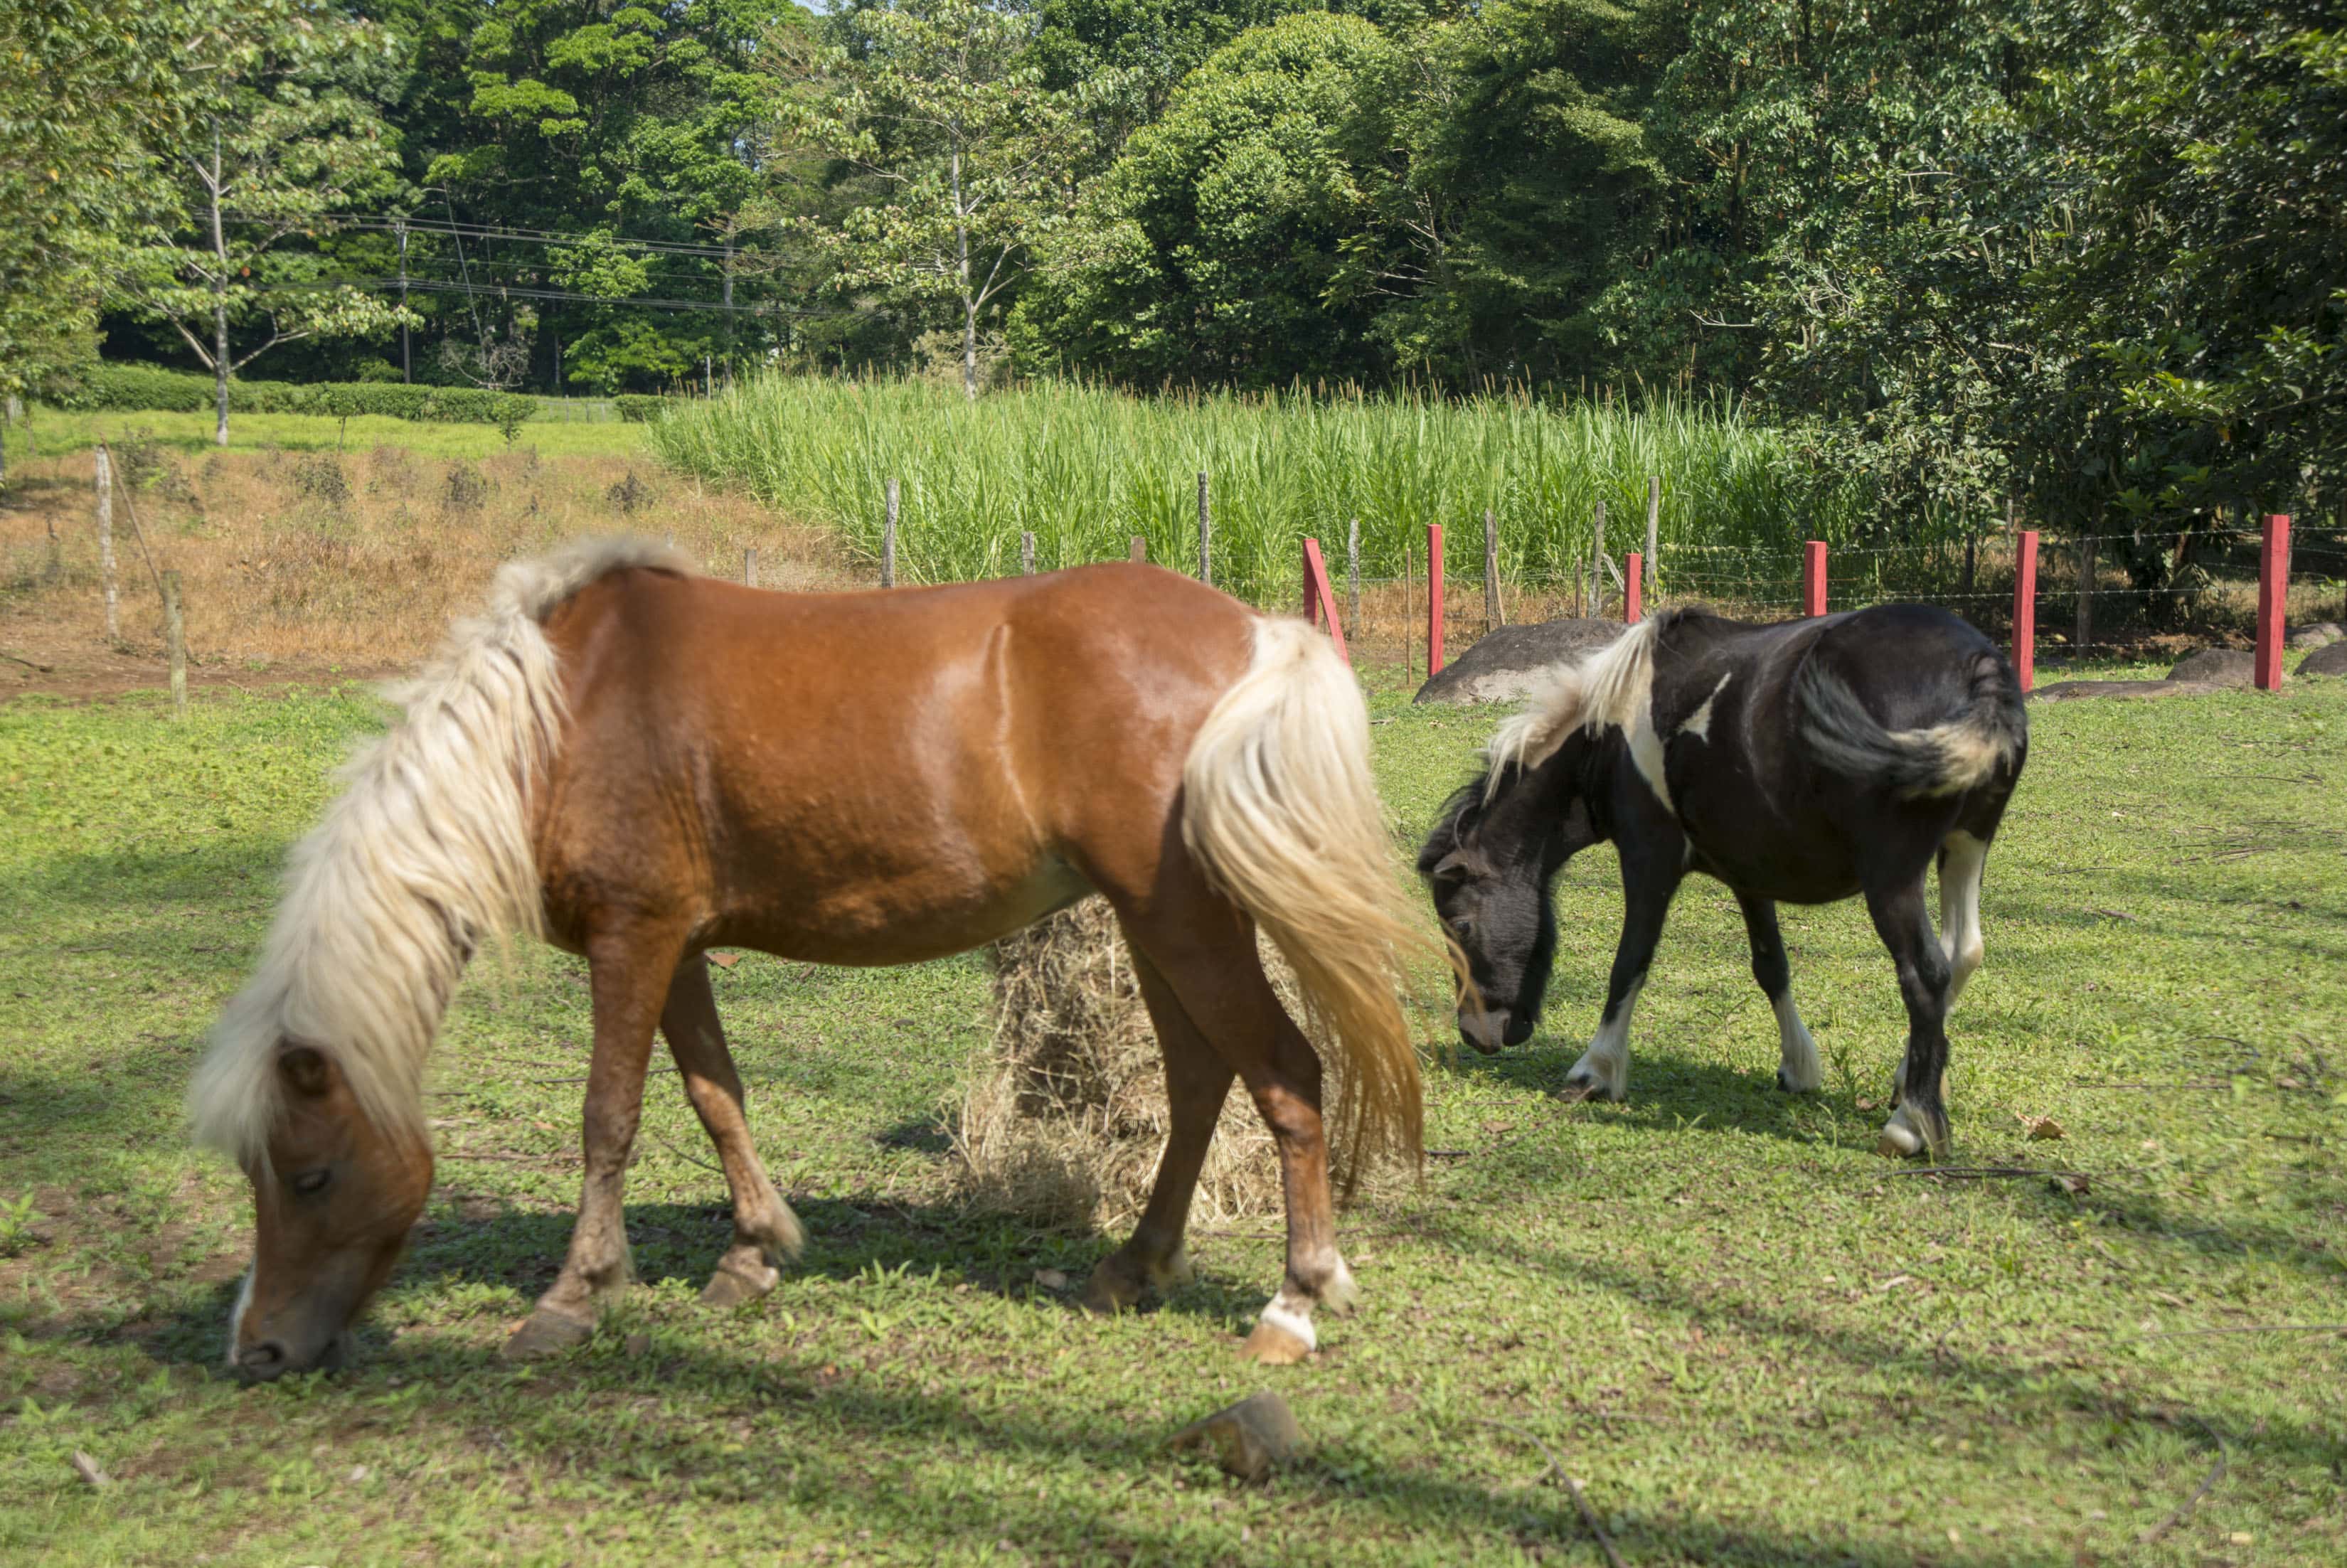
[{"x1": 0, "y1": 681, "x2": 2347, "y2": 1566}]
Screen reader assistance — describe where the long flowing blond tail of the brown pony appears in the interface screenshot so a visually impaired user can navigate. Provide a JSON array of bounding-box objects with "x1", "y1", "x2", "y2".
[{"x1": 1181, "y1": 617, "x2": 1439, "y2": 1183}]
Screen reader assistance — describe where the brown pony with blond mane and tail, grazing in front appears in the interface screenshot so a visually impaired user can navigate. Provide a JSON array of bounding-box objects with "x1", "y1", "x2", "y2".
[{"x1": 190, "y1": 540, "x2": 1425, "y2": 1378}]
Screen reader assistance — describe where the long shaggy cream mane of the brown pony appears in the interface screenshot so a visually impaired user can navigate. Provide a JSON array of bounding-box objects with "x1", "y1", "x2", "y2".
[{"x1": 188, "y1": 540, "x2": 690, "y2": 1162}]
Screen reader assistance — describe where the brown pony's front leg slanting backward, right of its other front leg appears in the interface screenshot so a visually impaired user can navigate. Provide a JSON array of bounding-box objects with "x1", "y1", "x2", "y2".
[{"x1": 659, "y1": 953, "x2": 807, "y2": 1308}]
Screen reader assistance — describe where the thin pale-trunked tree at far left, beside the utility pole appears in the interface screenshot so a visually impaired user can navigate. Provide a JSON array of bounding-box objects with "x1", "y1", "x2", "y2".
[{"x1": 112, "y1": 18, "x2": 417, "y2": 446}]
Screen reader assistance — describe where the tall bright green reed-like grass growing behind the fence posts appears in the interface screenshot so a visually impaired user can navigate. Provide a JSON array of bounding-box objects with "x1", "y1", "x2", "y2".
[{"x1": 650, "y1": 375, "x2": 1861, "y2": 603}]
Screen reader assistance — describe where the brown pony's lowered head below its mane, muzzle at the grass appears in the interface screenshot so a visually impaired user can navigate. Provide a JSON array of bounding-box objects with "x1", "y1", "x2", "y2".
[{"x1": 228, "y1": 1040, "x2": 432, "y2": 1378}]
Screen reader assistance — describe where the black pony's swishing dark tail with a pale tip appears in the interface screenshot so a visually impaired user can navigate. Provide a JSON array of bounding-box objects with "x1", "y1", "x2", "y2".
[{"x1": 1800, "y1": 653, "x2": 2031, "y2": 801}]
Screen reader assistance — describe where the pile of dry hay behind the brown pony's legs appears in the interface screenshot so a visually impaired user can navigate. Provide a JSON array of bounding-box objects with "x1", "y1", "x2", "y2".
[{"x1": 953, "y1": 897, "x2": 1371, "y2": 1230}]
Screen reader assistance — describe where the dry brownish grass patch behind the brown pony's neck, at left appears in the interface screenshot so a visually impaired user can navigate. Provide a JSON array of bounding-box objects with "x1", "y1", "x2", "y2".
[{"x1": 0, "y1": 439, "x2": 847, "y2": 673}]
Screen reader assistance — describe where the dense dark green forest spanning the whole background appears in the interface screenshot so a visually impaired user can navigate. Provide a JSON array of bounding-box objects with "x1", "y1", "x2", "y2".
[{"x1": 0, "y1": 0, "x2": 2347, "y2": 540}]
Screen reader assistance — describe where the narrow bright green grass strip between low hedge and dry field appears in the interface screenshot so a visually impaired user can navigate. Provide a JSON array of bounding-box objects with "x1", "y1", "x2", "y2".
[{"x1": 5, "y1": 408, "x2": 646, "y2": 465}]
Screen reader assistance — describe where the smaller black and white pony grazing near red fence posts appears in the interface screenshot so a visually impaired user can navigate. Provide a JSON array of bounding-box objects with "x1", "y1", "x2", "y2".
[{"x1": 1417, "y1": 606, "x2": 2028, "y2": 1155}]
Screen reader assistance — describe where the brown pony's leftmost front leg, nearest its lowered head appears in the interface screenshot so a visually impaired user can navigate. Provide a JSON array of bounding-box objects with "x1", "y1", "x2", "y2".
[{"x1": 505, "y1": 927, "x2": 683, "y2": 1359}]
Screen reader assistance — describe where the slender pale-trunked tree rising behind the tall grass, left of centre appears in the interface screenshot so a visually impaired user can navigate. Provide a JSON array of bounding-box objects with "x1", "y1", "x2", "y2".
[{"x1": 777, "y1": 0, "x2": 1085, "y2": 399}]
